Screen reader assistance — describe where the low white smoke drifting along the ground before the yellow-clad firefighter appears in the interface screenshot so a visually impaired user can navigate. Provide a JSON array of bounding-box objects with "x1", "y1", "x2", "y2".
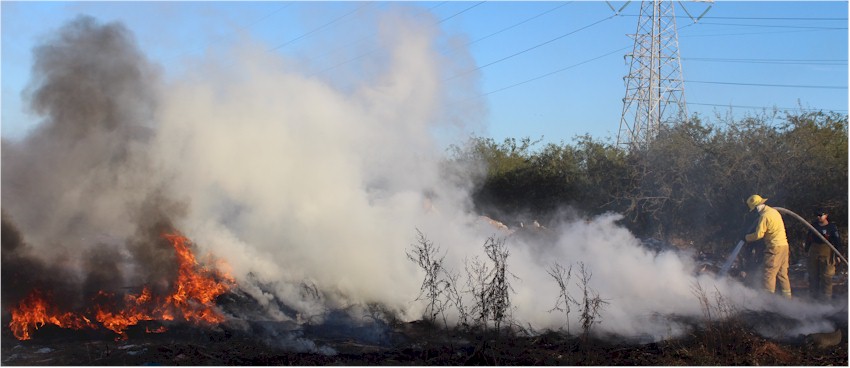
[{"x1": 504, "y1": 214, "x2": 846, "y2": 341}]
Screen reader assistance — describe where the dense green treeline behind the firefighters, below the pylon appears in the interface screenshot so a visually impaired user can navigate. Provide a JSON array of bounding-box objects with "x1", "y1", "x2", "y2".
[{"x1": 451, "y1": 112, "x2": 848, "y2": 258}]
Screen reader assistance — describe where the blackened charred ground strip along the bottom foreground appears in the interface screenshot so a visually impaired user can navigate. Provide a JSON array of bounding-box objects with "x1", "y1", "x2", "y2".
[{"x1": 2, "y1": 315, "x2": 848, "y2": 366}]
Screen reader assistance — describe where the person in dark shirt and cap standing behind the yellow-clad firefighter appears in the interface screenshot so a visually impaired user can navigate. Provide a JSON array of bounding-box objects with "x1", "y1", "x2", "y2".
[{"x1": 805, "y1": 210, "x2": 841, "y2": 300}]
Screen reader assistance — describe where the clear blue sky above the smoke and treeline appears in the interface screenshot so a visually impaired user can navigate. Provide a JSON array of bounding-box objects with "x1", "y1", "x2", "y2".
[{"x1": 1, "y1": 1, "x2": 848, "y2": 143}]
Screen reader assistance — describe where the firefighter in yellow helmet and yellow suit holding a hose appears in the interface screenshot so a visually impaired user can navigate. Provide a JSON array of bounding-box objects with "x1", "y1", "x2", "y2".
[{"x1": 744, "y1": 194, "x2": 791, "y2": 299}]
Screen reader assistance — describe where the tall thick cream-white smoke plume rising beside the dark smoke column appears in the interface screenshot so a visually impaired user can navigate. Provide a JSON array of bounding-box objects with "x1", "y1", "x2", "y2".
[{"x1": 147, "y1": 5, "x2": 484, "y2": 317}]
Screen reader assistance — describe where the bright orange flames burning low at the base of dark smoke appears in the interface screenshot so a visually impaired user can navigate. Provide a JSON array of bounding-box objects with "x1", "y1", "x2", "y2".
[{"x1": 9, "y1": 234, "x2": 234, "y2": 340}]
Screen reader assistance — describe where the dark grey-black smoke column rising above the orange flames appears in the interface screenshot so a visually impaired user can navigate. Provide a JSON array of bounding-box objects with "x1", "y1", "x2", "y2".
[{"x1": 2, "y1": 16, "x2": 184, "y2": 310}]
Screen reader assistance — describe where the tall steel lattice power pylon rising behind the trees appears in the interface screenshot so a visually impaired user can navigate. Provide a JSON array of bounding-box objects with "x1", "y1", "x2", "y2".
[{"x1": 617, "y1": 0, "x2": 688, "y2": 149}]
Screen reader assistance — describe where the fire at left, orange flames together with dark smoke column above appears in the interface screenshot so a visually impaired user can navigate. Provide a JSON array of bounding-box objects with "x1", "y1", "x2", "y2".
[{"x1": 2, "y1": 17, "x2": 235, "y2": 340}]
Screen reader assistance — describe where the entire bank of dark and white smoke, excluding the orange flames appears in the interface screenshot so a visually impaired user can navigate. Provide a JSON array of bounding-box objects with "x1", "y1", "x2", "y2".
[{"x1": 2, "y1": 8, "x2": 846, "y2": 346}]
